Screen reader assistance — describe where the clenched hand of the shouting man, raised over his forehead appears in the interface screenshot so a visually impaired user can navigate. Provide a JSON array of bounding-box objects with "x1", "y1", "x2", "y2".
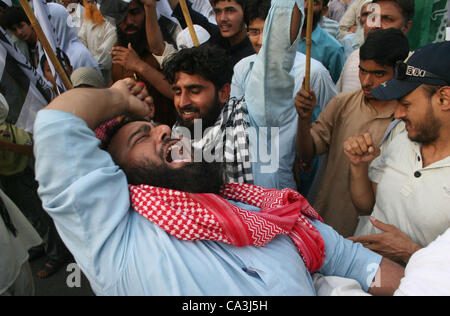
[{"x1": 110, "y1": 78, "x2": 154, "y2": 117}]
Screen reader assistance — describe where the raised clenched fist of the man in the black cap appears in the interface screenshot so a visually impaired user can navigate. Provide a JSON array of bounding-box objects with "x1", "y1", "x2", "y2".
[{"x1": 344, "y1": 133, "x2": 380, "y2": 167}]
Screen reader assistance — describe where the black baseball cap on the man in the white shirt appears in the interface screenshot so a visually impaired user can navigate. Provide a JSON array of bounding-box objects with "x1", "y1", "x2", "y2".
[{"x1": 370, "y1": 42, "x2": 450, "y2": 101}]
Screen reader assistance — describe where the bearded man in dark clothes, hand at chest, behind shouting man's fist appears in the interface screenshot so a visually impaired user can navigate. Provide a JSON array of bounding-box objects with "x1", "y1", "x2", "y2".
[{"x1": 107, "y1": 0, "x2": 175, "y2": 125}]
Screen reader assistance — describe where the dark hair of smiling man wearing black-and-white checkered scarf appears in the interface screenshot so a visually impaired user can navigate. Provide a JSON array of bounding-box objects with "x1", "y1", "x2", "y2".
[{"x1": 163, "y1": 44, "x2": 233, "y2": 89}]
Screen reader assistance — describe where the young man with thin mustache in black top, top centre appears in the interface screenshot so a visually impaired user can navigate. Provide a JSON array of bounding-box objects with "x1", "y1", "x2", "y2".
[{"x1": 169, "y1": 0, "x2": 255, "y2": 66}]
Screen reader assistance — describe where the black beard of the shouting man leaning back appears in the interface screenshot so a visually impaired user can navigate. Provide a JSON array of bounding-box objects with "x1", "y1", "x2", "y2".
[{"x1": 124, "y1": 162, "x2": 224, "y2": 194}]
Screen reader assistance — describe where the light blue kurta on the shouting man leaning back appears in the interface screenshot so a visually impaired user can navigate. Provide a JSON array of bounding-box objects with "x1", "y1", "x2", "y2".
[{"x1": 34, "y1": 0, "x2": 381, "y2": 296}]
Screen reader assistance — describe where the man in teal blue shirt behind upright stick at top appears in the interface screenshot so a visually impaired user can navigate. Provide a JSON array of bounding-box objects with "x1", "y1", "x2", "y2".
[{"x1": 298, "y1": 0, "x2": 345, "y2": 83}]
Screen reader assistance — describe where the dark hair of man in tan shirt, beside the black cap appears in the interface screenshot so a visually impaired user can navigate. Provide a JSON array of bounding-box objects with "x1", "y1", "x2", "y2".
[{"x1": 359, "y1": 28, "x2": 409, "y2": 67}]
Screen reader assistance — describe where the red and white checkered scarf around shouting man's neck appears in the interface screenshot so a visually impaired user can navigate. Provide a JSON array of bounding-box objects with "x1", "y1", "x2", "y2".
[{"x1": 129, "y1": 183, "x2": 325, "y2": 273}]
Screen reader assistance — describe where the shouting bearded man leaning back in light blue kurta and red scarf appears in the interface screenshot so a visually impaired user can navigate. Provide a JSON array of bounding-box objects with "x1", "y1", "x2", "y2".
[{"x1": 31, "y1": 0, "x2": 403, "y2": 296}]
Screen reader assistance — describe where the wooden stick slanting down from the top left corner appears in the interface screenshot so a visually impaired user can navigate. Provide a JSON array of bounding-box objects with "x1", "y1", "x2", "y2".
[{"x1": 19, "y1": 0, "x2": 72, "y2": 90}]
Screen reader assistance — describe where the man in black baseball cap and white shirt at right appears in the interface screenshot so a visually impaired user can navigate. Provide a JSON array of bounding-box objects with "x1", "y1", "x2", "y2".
[{"x1": 344, "y1": 42, "x2": 450, "y2": 263}]
